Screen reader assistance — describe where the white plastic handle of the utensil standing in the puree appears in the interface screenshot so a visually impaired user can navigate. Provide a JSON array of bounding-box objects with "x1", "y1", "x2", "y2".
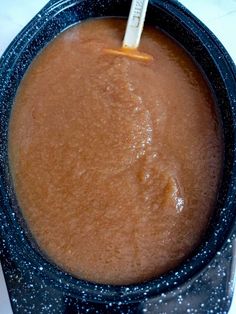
[{"x1": 123, "y1": 0, "x2": 148, "y2": 49}]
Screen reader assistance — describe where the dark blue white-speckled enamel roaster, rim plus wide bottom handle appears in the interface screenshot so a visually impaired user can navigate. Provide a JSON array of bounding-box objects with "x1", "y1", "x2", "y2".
[{"x1": 0, "y1": 0, "x2": 236, "y2": 314}]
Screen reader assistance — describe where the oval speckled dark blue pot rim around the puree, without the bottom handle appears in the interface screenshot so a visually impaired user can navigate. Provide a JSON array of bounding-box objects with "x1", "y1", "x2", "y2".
[{"x1": 0, "y1": 0, "x2": 236, "y2": 310}]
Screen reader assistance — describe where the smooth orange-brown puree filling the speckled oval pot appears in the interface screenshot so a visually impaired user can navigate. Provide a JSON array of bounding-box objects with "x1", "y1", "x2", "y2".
[{"x1": 9, "y1": 19, "x2": 222, "y2": 284}]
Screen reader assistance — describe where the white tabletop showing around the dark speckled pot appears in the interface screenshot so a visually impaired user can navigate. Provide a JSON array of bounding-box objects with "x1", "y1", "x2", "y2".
[{"x1": 0, "y1": 0, "x2": 236, "y2": 314}]
